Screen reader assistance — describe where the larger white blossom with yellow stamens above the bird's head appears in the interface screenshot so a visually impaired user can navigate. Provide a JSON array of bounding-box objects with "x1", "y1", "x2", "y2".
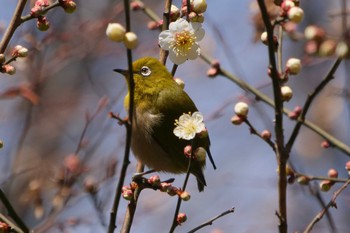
[{"x1": 159, "y1": 18, "x2": 205, "y2": 65}]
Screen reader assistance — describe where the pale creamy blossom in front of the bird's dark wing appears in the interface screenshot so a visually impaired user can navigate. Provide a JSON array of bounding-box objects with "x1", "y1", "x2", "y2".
[{"x1": 173, "y1": 112, "x2": 205, "y2": 140}]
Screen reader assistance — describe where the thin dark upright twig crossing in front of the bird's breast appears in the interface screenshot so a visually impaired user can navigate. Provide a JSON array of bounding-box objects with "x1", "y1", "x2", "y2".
[{"x1": 108, "y1": 0, "x2": 135, "y2": 233}]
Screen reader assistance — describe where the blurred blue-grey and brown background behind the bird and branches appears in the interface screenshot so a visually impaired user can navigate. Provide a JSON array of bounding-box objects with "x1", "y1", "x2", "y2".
[{"x1": 0, "y1": 0, "x2": 350, "y2": 233}]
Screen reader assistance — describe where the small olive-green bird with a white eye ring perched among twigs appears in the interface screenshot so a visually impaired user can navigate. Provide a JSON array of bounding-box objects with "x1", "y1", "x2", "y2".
[{"x1": 114, "y1": 57, "x2": 216, "y2": 191}]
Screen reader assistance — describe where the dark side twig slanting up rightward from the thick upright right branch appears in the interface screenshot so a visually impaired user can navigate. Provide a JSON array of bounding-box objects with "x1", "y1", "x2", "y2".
[{"x1": 286, "y1": 58, "x2": 342, "y2": 152}]
